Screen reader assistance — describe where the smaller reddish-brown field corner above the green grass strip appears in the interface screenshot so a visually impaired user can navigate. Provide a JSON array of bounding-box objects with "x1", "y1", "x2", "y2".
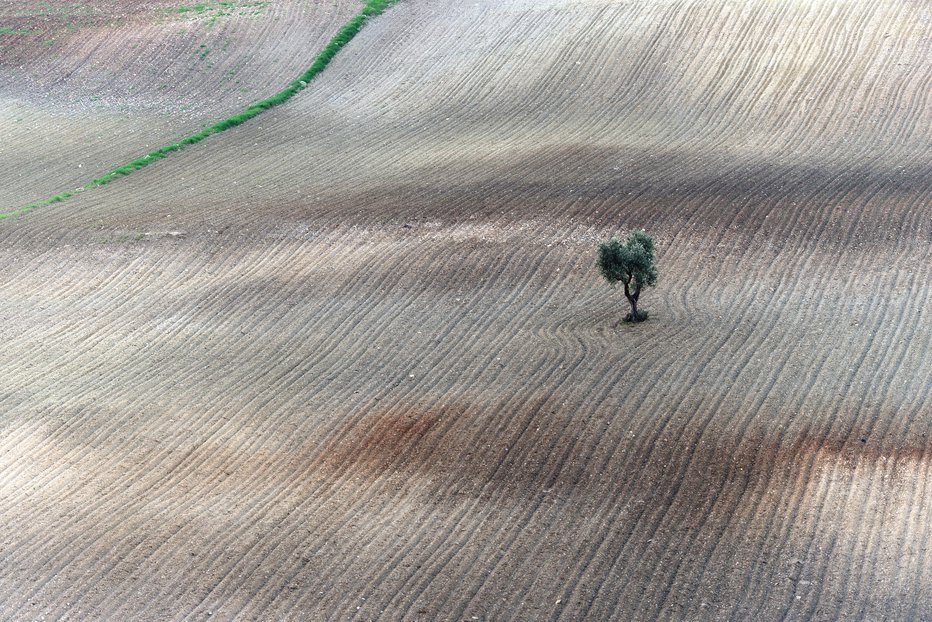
[{"x1": 0, "y1": 0, "x2": 359, "y2": 212}]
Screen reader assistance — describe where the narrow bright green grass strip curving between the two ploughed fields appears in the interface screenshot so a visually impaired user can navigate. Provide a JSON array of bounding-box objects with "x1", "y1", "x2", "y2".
[{"x1": 0, "y1": 0, "x2": 398, "y2": 220}]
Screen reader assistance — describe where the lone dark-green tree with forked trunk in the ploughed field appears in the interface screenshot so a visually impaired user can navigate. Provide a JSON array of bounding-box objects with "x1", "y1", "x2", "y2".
[{"x1": 595, "y1": 231, "x2": 657, "y2": 322}]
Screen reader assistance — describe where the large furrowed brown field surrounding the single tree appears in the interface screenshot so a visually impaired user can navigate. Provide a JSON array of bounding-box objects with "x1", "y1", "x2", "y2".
[{"x1": 0, "y1": 0, "x2": 932, "y2": 620}]
